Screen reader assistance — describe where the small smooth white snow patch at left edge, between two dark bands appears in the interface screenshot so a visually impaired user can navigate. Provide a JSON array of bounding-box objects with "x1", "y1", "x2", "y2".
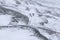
[{"x1": 0, "y1": 15, "x2": 11, "y2": 26}]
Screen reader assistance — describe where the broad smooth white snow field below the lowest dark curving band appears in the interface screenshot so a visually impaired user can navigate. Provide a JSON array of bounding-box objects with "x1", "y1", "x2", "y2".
[{"x1": 0, "y1": 28, "x2": 39, "y2": 40}]
